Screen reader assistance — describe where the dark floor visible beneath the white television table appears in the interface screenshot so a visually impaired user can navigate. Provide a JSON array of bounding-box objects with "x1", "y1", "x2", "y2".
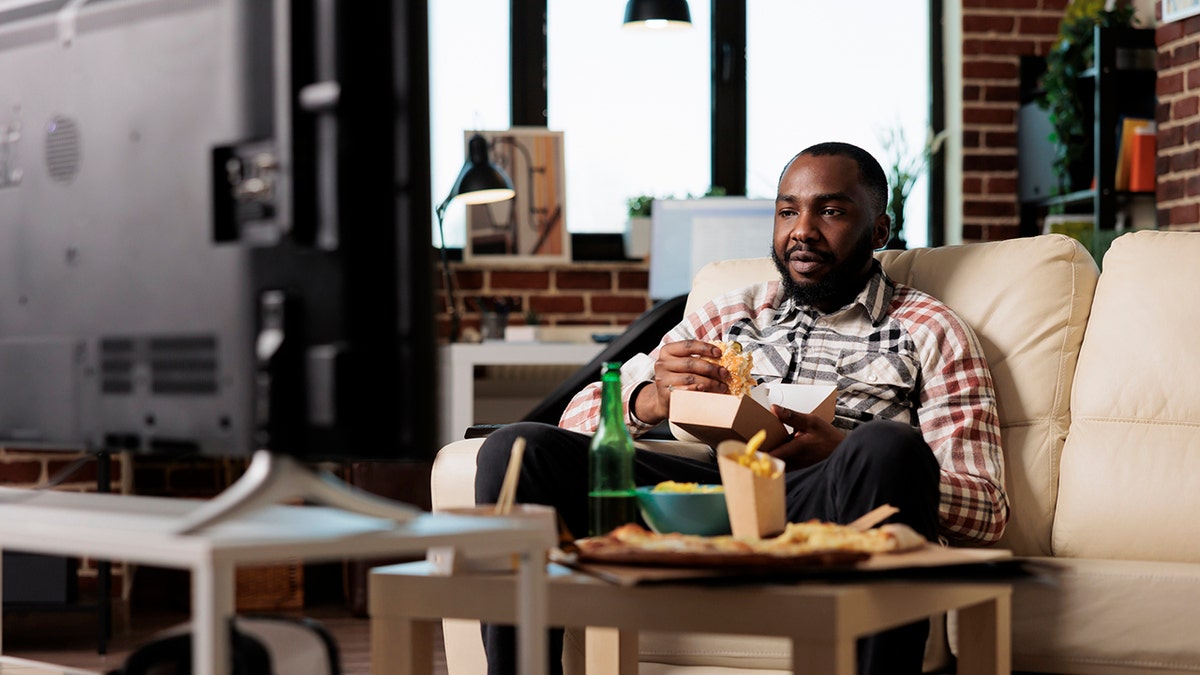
[{"x1": 4, "y1": 604, "x2": 446, "y2": 675}]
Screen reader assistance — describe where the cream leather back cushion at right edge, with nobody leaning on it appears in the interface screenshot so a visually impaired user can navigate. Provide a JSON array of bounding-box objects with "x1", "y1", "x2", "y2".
[{"x1": 1054, "y1": 231, "x2": 1200, "y2": 562}]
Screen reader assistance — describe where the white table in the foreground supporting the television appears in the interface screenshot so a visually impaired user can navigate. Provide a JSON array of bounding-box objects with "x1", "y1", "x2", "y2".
[{"x1": 0, "y1": 488, "x2": 556, "y2": 675}]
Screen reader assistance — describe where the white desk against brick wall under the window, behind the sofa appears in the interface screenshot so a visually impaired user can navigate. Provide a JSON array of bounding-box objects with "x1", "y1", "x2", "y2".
[{"x1": 438, "y1": 341, "x2": 604, "y2": 447}]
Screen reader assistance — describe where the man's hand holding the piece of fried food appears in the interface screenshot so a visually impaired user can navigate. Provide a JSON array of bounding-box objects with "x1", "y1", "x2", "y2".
[{"x1": 634, "y1": 340, "x2": 730, "y2": 424}]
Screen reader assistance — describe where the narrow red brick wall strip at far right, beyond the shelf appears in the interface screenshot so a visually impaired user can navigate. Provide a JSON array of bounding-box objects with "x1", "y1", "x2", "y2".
[{"x1": 1154, "y1": 2, "x2": 1200, "y2": 231}]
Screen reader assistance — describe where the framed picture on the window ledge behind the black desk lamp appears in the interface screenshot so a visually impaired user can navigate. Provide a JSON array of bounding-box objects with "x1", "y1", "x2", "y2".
[{"x1": 463, "y1": 127, "x2": 571, "y2": 264}]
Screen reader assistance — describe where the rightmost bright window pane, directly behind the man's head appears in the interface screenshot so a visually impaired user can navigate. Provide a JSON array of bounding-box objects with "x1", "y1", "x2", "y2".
[{"x1": 746, "y1": 0, "x2": 930, "y2": 247}]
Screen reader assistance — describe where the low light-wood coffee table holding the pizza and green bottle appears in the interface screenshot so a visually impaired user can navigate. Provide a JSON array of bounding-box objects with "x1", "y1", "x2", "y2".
[{"x1": 370, "y1": 562, "x2": 1012, "y2": 675}]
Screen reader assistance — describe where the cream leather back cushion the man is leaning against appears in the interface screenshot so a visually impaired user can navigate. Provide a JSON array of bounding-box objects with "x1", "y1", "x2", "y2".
[{"x1": 686, "y1": 234, "x2": 1098, "y2": 555}]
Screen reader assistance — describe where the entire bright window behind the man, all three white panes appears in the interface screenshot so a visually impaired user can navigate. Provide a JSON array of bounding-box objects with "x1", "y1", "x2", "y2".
[{"x1": 430, "y1": 0, "x2": 930, "y2": 246}]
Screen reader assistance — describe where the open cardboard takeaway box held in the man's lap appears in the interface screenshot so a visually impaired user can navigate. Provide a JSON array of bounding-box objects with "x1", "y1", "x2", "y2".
[{"x1": 670, "y1": 384, "x2": 838, "y2": 450}]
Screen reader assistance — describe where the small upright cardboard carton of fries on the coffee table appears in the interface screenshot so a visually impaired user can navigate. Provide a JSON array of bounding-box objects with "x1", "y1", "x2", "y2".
[{"x1": 716, "y1": 441, "x2": 787, "y2": 539}]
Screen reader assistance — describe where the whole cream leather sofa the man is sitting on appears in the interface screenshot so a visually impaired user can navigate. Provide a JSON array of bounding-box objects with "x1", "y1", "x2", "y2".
[{"x1": 432, "y1": 231, "x2": 1200, "y2": 675}]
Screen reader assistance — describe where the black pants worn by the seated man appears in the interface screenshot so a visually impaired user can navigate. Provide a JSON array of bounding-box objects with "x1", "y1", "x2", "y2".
[{"x1": 475, "y1": 420, "x2": 940, "y2": 675}]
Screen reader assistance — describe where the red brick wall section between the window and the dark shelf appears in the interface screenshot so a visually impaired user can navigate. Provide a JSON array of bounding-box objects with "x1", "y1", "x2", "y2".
[{"x1": 962, "y1": 0, "x2": 1069, "y2": 241}]
